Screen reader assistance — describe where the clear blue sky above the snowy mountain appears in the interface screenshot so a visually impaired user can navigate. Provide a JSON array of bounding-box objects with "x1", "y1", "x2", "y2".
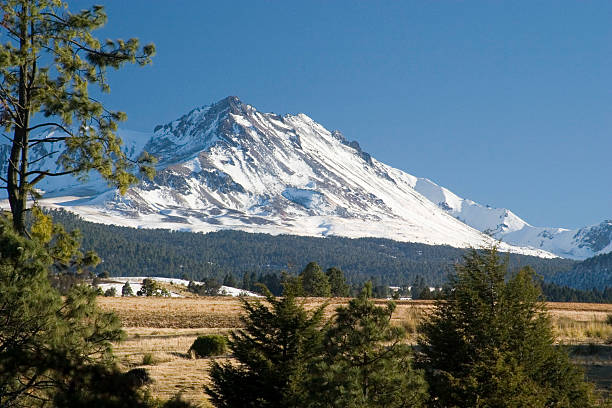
[{"x1": 93, "y1": 0, "x2": 612, "y2": 228}]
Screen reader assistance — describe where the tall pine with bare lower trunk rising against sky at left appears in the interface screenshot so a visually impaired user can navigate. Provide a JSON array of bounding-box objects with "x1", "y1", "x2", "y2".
[{"x1": 0, "y1": 0, "x2": 155, "y2": 235}]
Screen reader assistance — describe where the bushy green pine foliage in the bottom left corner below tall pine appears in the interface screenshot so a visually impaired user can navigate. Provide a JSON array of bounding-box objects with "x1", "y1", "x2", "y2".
[{"x1": 0, "y1": 220, "x2": 151, "y2": 408}]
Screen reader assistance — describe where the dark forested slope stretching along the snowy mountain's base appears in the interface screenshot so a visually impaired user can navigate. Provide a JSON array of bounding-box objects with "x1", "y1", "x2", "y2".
[{"x1": 46, "y1": 211, "x2": 576, "y2": 286}]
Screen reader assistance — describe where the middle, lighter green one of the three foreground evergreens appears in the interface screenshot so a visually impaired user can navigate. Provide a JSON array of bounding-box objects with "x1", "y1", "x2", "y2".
[{"x1": 308, "y1": 284, "x2": 427, "y2": 408}]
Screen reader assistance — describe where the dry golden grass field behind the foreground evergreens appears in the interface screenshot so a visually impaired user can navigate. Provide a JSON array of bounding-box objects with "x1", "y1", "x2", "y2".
[{"x1": 99, "y1": 297, "x2": 612, "y2": 407}]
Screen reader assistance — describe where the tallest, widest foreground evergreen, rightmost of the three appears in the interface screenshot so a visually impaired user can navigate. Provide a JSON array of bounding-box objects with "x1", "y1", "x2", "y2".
[{"x1": 419, "y1": 249, "x2": 594, "y2": 408}]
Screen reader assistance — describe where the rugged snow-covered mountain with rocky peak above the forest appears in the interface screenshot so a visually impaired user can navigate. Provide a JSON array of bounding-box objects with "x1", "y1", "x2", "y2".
[{"x1": 0, "y1": 97, "x2": 610, "y2": 257}]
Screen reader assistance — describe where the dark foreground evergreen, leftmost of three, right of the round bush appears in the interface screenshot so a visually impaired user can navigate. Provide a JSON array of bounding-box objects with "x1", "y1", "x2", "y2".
[{"x1": 205, "y1": 292, "x2": 324, "y2": 408}]
